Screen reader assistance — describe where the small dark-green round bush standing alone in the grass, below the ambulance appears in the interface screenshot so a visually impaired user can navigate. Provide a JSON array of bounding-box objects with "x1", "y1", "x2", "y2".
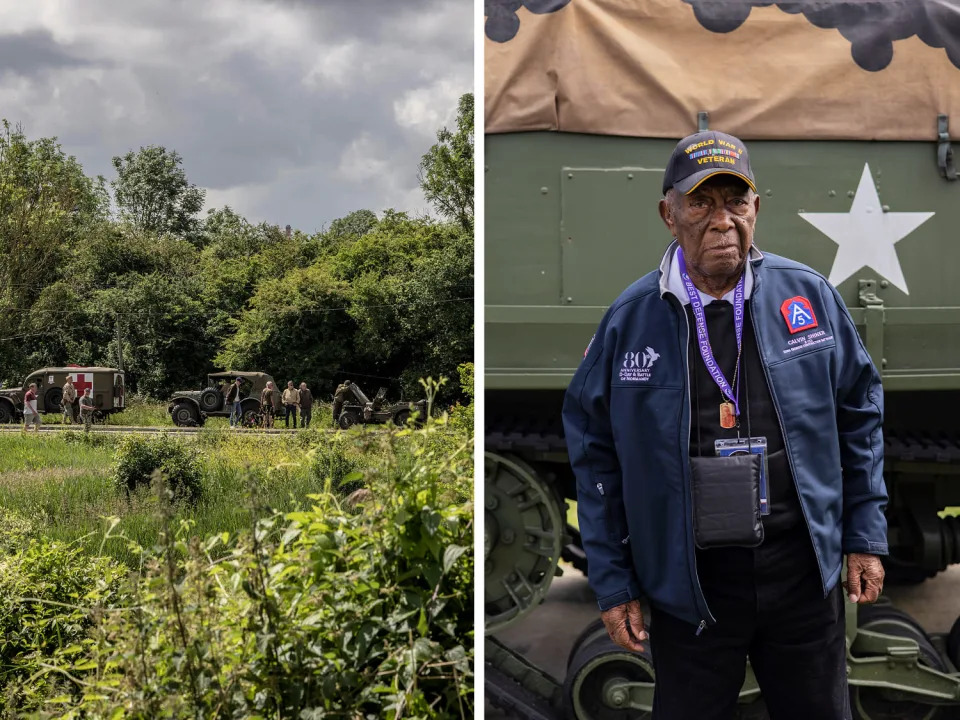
[{"x1": 113, "y1": 435, "x2": 202, "y2": 501}]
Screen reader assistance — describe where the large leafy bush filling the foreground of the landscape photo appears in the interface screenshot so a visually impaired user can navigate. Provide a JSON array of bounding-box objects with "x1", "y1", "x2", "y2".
[{"x1": 34, "y1": 428, "x2": 473, "y2": 720}]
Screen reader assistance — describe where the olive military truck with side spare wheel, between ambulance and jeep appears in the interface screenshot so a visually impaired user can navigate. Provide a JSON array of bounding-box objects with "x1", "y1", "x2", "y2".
[{"x1": 167, "y1": 370, "x2": 282, "y2": 427}]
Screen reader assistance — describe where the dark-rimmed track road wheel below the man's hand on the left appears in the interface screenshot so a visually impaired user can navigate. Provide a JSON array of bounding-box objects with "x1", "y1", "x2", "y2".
[{"x1": 563, "y1": 635, "x2": 654, "y2": 720}]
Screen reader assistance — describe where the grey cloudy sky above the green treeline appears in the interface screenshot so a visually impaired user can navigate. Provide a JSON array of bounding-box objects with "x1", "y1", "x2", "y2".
[{"x1": 0, "y1": 0, "x2": 473, "y2": 232}]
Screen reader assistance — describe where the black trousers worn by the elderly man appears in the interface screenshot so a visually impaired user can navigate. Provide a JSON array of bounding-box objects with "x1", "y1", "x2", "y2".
[{"x1": 650, "y1": 540, "x2": 851, "y2": 720}]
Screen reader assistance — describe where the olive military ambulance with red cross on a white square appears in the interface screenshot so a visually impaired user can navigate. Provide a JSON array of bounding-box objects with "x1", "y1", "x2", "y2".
[{"x1": 0, "y1": 365, "x2": 124, "y2": 423}]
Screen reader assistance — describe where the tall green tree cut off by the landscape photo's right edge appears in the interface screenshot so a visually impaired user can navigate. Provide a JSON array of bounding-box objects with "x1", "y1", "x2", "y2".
[{"x1": 417, "y1": 93, "x2": 473, "y2": 232}]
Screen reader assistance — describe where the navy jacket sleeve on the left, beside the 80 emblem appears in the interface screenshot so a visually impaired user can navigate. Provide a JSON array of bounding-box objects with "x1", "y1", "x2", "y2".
[{"x1": 563, "y1": 313, "x2": 640, "y2": 610}]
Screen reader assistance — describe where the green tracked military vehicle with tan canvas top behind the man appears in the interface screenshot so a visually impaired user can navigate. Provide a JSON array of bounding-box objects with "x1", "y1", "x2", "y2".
[{"x1": 482, "y1": 0, "x2": 960, "y2": 720}]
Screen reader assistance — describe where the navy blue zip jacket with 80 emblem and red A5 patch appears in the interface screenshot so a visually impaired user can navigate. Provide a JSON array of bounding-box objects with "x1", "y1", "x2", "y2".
[{"x1": 563, "y1": 244, "x2": 887, "y2": 628}]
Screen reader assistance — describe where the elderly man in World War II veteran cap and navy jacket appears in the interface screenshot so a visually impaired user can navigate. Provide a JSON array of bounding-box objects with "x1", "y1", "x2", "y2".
[{"x1": 563, "y1": 132, "x2": 887, "y2": 720}]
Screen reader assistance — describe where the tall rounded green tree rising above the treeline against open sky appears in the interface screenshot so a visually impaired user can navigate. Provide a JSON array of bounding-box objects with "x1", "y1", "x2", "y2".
[{"x1": 111, "y1": 145, "x2": 205, "y2": 242}]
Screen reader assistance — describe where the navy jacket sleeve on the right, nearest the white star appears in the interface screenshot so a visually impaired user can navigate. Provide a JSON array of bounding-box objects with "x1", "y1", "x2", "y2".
[{"x1": 825, "y1": 286, "x2": 888, "y2": 555}]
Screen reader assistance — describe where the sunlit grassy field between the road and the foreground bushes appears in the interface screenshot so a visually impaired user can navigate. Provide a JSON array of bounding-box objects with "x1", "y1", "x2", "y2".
[{"x1": 0, "y1": 428, "x2": 408, "y2": 566}]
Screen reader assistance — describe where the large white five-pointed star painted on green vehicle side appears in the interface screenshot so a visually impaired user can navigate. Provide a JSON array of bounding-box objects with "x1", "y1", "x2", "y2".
[{"x1": 797, "y1": 164, "x2": 934, "y2": 294}]
